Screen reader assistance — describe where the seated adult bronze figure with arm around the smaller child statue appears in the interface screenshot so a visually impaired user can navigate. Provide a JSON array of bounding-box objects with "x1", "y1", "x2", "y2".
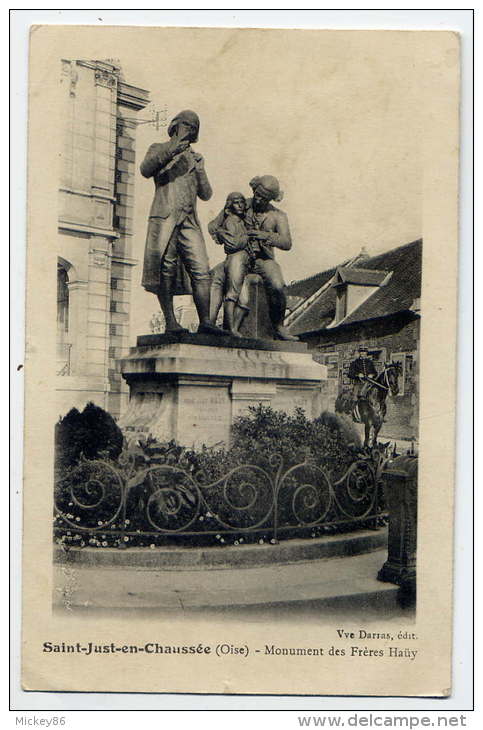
[{"x1": 210, "y1": 175, "x2": 298, "y2": 340}]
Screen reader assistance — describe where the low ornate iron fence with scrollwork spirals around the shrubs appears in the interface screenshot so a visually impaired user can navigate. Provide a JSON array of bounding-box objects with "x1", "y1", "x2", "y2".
[{"x1": 54, "y1": 452, "x2": 383, "y2": 547}]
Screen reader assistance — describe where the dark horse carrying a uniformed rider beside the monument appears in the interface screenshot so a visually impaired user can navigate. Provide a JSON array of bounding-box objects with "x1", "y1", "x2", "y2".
[{"x1": 335, "y1": 362, "x2": 402, "y2": 449}]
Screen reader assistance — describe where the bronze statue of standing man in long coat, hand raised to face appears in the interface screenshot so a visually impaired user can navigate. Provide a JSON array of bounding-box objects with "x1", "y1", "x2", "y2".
[{"x1": 141, "y1": 109, "x2": 226, "y2": 335}]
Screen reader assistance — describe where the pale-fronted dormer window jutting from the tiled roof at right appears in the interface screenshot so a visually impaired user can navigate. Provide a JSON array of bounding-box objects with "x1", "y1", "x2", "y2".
[{"x1": 329, "y1": 266, "x2": 392, "y2": 327}]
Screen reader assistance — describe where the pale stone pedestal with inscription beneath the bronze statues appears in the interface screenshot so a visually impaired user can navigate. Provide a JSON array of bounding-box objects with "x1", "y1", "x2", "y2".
[{"x1": 119, "y1": 334, "x2": 327, "y2": 447}]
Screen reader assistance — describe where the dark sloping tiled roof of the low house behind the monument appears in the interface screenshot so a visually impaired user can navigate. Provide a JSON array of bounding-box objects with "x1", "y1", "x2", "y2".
[{"x1": 287, "y1": 239, "x2": 422, "y2": 335}]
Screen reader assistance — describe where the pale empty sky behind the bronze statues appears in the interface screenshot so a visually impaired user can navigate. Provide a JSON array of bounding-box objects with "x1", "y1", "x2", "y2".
[{"x1": 109, "y1": 30, "x2": 422, "y2": 341}]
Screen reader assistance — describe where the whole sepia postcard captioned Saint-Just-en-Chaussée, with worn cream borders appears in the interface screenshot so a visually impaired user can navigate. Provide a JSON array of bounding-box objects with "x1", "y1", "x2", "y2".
[{"x1": 22, "y1": 25, "x2": 460, "y2": 697}]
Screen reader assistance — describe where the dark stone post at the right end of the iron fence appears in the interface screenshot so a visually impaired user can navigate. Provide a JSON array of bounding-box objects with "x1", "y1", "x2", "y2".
[{"x1": 377, "y1": 456, "x2": 418, "y2": 602}]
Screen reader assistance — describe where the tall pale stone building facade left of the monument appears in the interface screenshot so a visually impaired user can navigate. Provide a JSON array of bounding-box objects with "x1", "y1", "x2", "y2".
[{"x1": 56, "y1": 60, "x2": 149, "y2": 417}]
